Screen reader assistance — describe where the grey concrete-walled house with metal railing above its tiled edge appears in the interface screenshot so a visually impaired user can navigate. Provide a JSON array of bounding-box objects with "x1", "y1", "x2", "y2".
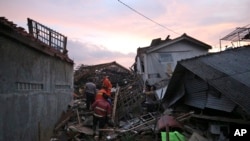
[{"x1": 0, "y1": 17, "x2": 74, "y2": 141}]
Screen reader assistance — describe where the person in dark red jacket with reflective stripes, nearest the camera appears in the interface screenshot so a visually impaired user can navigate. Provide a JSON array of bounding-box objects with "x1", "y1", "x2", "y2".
[{"x1": 91, "y1": 93, "x2": 111, "y2": 138}]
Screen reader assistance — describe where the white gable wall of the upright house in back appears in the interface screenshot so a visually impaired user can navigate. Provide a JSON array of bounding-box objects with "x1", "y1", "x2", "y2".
[{"x1": 143, "y1": 41, "x2": 208, "y2": 83}]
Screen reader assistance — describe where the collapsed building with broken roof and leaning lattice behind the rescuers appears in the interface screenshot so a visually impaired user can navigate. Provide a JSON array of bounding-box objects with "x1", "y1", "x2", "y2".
[{"x1": 74, "y1": 61, "x2": 143, "y2": 119}]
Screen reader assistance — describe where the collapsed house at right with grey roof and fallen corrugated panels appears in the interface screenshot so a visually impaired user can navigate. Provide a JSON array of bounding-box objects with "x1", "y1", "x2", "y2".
[{"x1": 163, "y1": 45, "x2": 250, "y2": 140}]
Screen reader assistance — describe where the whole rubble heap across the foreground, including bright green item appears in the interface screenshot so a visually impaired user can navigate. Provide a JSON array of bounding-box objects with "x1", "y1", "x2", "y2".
[{"x1": 51, "y1": 63, "x2": 250, "y2": 141}]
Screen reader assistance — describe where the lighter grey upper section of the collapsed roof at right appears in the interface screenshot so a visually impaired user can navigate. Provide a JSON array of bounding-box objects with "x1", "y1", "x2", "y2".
[{"x1": 181, "y1": 46, "x2": 250, "y2": 87}]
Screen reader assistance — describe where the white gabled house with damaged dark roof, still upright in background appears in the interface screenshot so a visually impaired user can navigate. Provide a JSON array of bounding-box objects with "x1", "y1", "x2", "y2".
[{"x1": 134, "y1": 34, "x2": 212, "y2": 97}]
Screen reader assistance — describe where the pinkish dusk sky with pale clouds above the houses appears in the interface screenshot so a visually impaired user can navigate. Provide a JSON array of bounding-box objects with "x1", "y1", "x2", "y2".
[{"x1": 0, "y1": 0, "x2": 250, "y2": 68}]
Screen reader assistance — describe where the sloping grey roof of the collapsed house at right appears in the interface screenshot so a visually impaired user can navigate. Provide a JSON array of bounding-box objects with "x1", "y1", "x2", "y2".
[{"x1": 166, "y1": 46, "x2": 250, "y2": 114}]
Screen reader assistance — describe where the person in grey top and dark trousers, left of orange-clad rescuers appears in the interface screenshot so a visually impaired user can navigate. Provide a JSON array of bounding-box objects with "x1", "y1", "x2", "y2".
[{"x1": 84, "y1": 78, "x2": 96, "y2": 110}]
